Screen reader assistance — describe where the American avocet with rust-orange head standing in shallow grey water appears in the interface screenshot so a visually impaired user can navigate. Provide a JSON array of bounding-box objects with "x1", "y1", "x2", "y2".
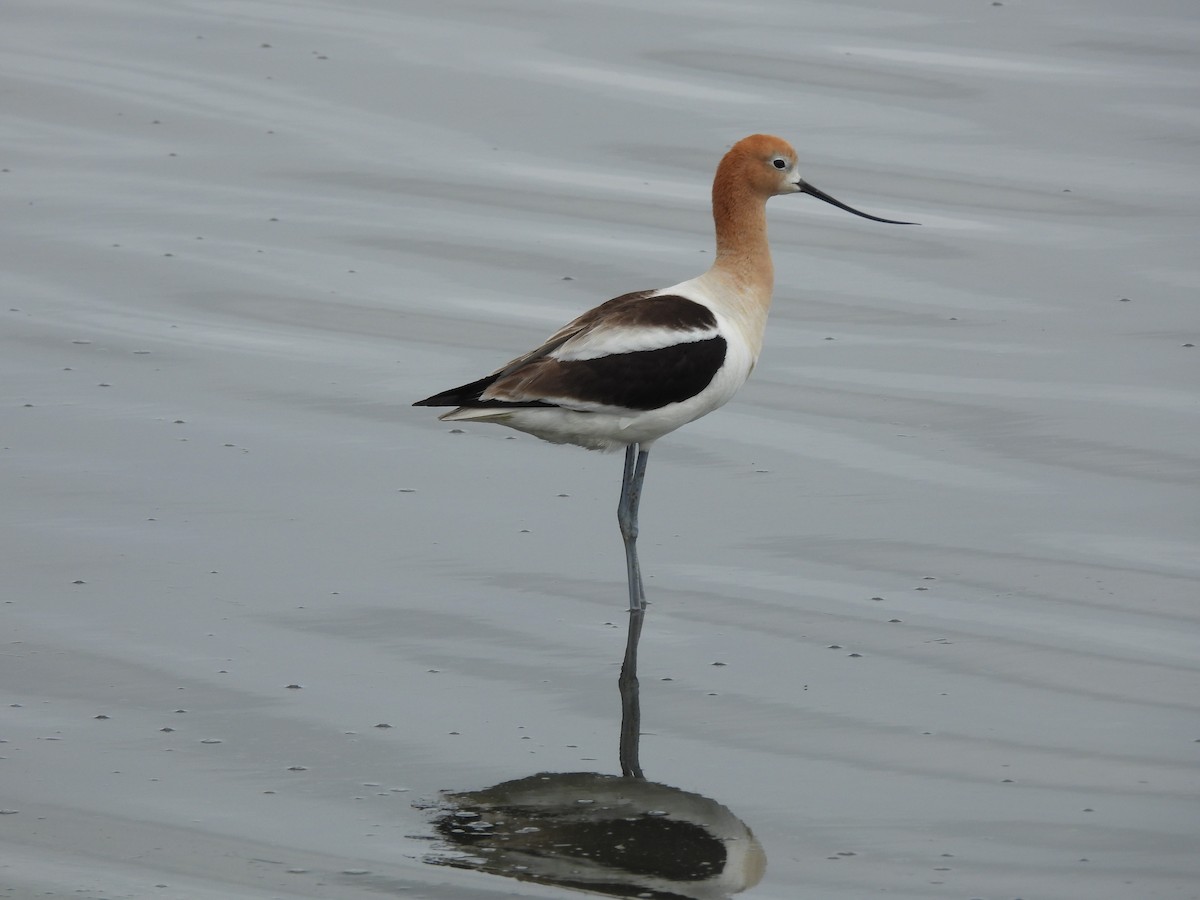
[{"x1": 413, "y1": 134, "x2": 914, "y2": 646}]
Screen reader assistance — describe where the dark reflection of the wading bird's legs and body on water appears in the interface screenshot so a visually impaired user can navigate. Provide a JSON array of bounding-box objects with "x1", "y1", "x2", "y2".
[{"x1": 425, "y1": 610, "x2": 767, "y2": 900}]
